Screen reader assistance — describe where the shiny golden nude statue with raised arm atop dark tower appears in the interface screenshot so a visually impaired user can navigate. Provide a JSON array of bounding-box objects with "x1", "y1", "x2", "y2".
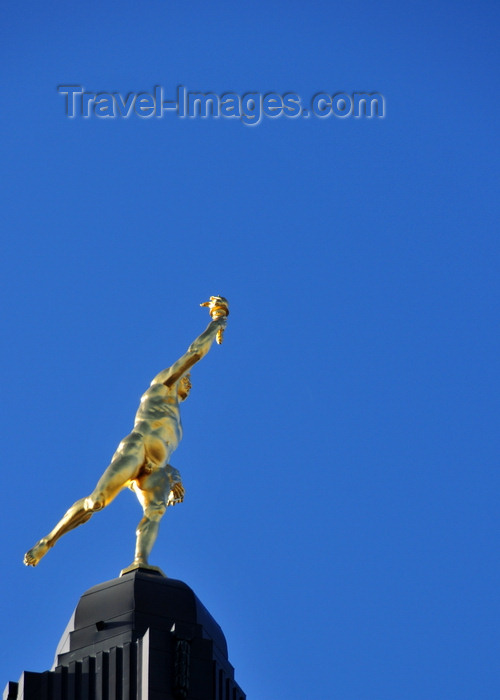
[{"x1": 24, "y1": 296, "x2": 229, "y2": 573}]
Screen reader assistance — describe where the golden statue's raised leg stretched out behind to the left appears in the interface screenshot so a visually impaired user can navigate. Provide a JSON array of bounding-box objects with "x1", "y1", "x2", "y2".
[{"x1": 24, "y1": 433, "x2": 144, "y2": 566}]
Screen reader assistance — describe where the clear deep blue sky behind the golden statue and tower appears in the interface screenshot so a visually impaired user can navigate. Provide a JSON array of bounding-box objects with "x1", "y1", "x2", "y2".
[{"x1": 0, "y1": 0, "x2": 500, "y2": 700}]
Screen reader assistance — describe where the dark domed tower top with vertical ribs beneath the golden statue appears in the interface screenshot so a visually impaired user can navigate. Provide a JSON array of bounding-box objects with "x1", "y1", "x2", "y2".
[{"x1": 4, "y1": 569, "x2": 246, "y2": 700}]
